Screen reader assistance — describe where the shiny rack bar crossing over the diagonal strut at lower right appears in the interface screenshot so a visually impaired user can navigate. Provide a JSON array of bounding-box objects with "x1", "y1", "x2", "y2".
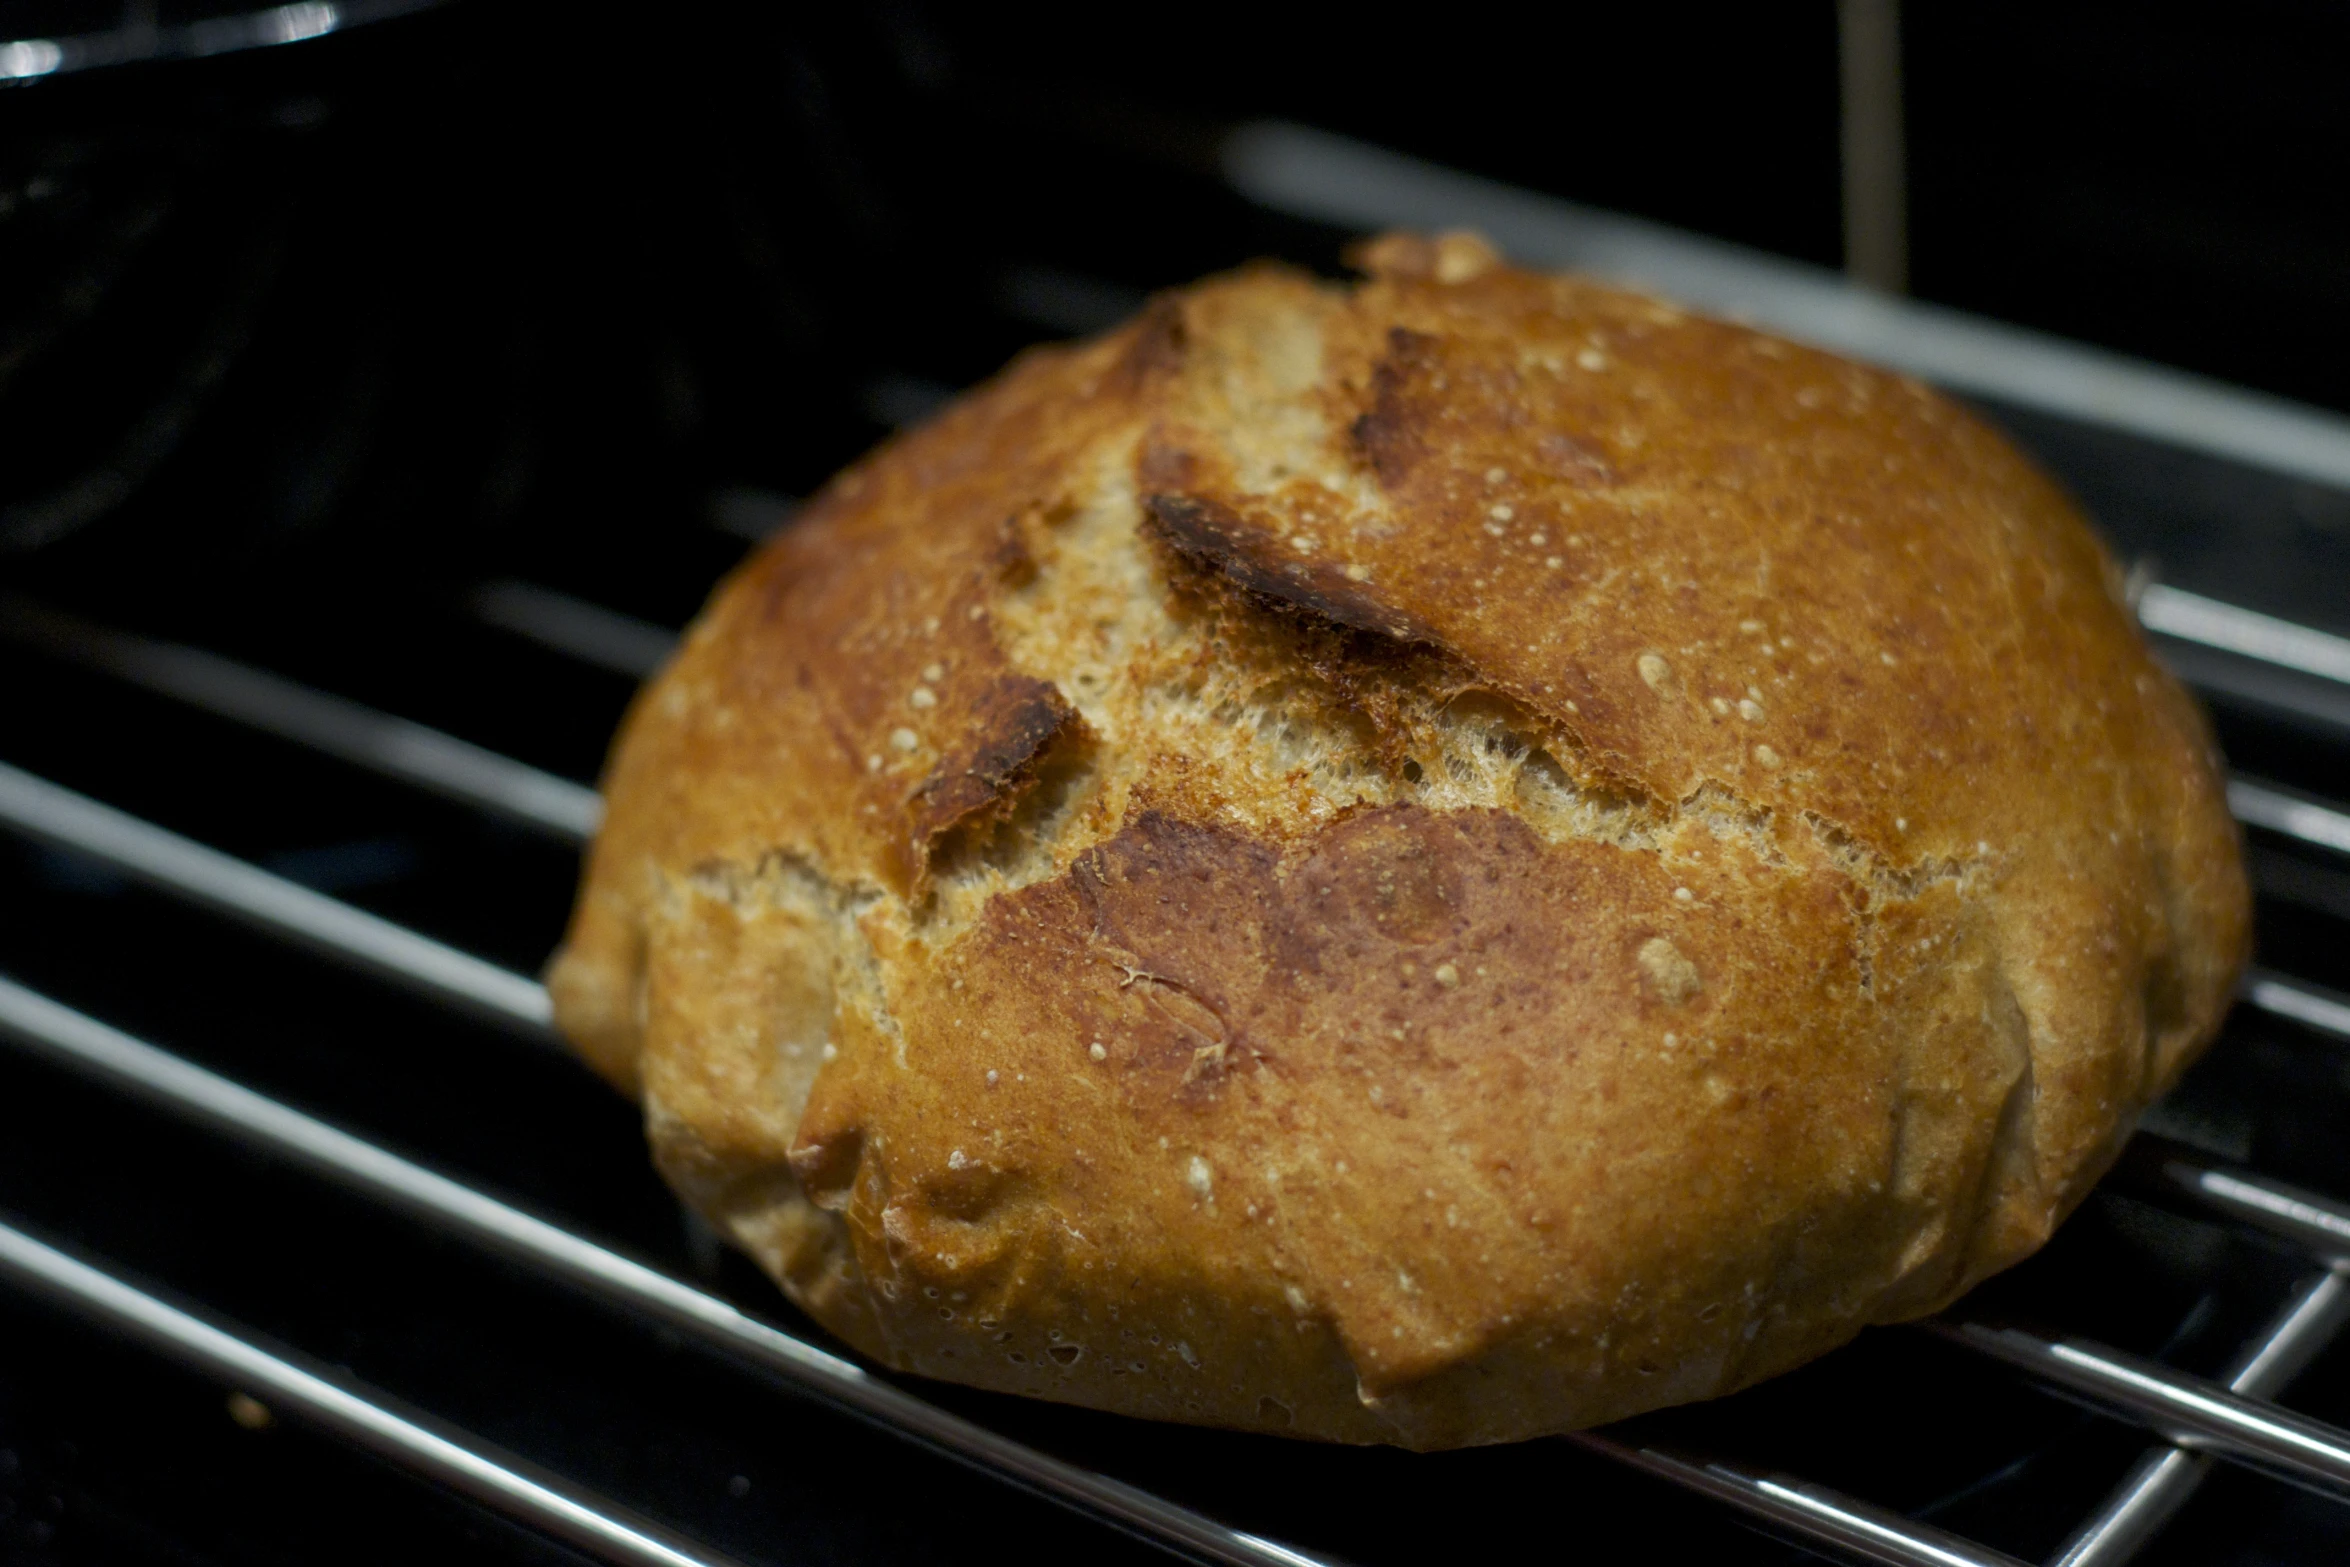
[{"x1": 1927, "y1": 1323, "x2": 2350, "y2": 1497}]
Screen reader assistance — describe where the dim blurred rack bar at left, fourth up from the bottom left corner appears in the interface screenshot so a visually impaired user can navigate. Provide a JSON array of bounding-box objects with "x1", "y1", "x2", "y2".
[{"x1": 0, "y1": 599, "x2": 604, "y2": 843}]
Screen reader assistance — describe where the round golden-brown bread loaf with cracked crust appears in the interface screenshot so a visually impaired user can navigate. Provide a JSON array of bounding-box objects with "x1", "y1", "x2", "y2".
[{"x1": 550, "y1": 235, "x2": 2249, "y2": 1447}]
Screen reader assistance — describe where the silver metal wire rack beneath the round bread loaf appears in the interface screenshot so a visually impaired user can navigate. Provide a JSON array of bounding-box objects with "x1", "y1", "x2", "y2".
[{"x1": 0, "y1": 127, "x2": 2350, "y2": 1567}]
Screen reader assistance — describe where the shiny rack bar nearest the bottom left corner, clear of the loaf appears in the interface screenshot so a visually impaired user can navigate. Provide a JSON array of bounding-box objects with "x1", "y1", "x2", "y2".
[{"x1": 0, "y1": 1224, "x2": 733, "y2": 1567}]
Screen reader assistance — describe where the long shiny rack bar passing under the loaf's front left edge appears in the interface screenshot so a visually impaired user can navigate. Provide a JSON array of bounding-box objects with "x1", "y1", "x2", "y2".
[{"x1": 0, "y1": 980, "x2": 1330, "y2": 1567}]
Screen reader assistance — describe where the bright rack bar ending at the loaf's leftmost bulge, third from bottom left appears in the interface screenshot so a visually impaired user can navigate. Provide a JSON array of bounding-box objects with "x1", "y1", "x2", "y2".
[{"x1": 0, "y1": 764, "x2": 552, "y2": 1038}]
